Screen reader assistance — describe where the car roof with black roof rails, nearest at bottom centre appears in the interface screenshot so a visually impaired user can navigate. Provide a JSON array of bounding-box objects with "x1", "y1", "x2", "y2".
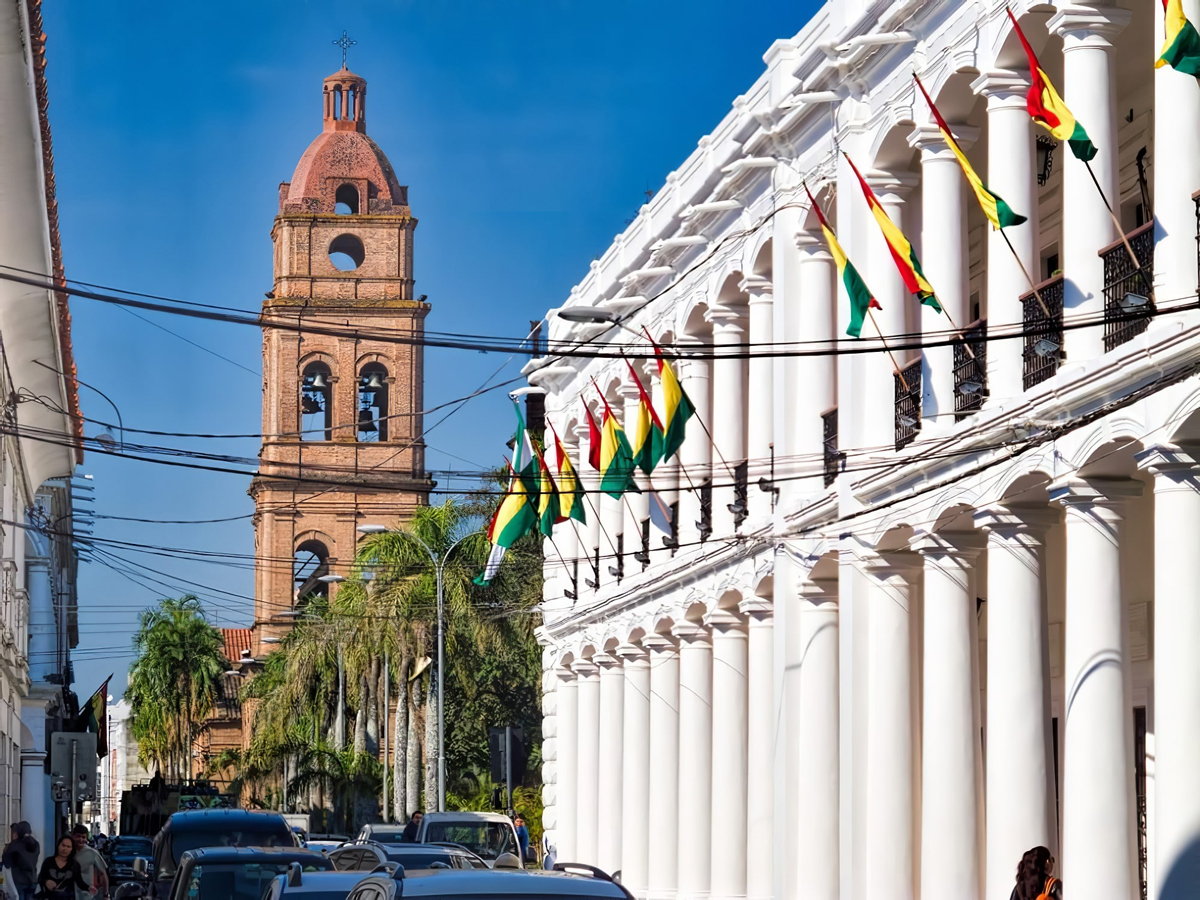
[{"x1": 346, "y1": 863, "x2": 634, "y2": 900}]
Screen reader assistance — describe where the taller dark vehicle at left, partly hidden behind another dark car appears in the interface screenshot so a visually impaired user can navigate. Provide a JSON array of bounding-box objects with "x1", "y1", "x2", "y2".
[{"x1": 129, "y1": 809, "x2": 298, "y2": 900}]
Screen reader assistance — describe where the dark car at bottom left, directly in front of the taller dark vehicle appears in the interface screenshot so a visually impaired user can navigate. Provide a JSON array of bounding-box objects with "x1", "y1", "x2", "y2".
[{"x1": 161, "y1": 847, "x2": 332, "y2": 900}]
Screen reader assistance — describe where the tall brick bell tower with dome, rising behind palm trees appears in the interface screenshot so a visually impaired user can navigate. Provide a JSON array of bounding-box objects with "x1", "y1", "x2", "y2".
[{"x1": 250, "y1": 65, "x2": 433, "y2": 656}]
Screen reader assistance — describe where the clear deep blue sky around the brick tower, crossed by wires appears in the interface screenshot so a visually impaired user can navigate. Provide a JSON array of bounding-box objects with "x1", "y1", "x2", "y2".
[{"x1": 44, "y1": 0, "x2": 817, "y2": 696}]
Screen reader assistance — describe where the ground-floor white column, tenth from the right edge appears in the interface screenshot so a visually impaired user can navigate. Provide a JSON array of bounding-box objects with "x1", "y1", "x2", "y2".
[{"x1": 642, "y1": 635, "x2": 679, "y2": 900}]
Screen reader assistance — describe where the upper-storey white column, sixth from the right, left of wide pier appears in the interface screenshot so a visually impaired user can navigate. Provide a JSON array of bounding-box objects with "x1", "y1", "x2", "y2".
[{"x1": 786, "y1": 232, "x2": 840, "y2": 494}]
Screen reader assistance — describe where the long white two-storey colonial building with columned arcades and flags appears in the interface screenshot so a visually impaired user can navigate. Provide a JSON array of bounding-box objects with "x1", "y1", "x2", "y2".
[{"x1": 526, "y1": 0, "x2": 1200, "y2": 900}]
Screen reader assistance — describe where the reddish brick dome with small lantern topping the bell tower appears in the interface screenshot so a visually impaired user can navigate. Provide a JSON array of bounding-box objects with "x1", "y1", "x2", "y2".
[{"x1": 280, "y1": 67, "x2": 409, "y2": 216}]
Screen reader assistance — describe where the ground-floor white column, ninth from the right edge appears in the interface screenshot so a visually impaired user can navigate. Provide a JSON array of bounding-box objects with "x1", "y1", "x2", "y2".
[{"x1": 674, "y1": 622, "x2": 713, "y2": 900}]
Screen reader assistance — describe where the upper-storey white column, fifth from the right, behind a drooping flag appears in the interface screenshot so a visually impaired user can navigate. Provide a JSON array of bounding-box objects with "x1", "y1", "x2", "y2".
[{"x1": 864, "y1": 172, "x2": 919, "y2": 448}]
